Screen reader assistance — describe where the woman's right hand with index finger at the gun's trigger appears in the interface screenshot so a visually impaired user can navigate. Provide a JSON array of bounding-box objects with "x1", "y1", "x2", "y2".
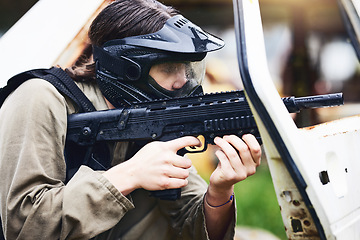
[{"x1": 103, "y1": 136, "x2": 201, "y2": 195}]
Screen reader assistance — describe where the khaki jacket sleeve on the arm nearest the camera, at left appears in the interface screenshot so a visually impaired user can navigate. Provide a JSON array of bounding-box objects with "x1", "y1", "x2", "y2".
[{"x1": 0, "y1": 79, "x2": 134, "y2": 239}]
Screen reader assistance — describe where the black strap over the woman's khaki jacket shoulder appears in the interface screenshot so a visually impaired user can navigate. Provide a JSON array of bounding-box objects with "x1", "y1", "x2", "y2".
[{"x1": 0, "y1": 67, "x2": 96, "y2": 112}]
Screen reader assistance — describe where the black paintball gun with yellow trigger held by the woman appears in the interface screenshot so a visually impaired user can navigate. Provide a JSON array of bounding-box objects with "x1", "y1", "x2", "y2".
[{"x1": 67, "y1": 91, "x2": 343, "y2": 200}]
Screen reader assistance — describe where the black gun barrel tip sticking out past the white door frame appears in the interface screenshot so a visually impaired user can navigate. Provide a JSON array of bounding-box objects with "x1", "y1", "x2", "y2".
[{"x1": 283, "y1": 93, "x2": 344, "y2": 112}]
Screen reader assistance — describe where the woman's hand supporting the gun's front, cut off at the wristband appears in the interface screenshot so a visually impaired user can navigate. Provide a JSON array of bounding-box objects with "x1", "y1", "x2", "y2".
[{"x1": 206, "y1": 134, "x2": 261, "y2": 206}]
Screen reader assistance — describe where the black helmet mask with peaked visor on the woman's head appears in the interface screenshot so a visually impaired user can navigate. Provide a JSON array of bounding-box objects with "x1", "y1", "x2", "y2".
[{"x1": 93, "y1": 15, "x2": 224, "y2": 108}]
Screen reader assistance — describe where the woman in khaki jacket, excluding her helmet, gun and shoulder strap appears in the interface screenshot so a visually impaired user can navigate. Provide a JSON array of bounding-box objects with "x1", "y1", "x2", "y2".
[{"x1": 0, "y1": 0, "x2": 260, "y2": 239}]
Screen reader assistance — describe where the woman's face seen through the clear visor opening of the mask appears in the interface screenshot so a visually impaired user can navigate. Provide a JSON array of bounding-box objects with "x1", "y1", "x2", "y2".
[{"x1": 149, "y1": 62, "x2": 187, "y2": 91}]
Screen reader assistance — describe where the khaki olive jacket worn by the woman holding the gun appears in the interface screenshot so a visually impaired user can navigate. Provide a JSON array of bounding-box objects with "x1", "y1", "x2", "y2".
[{"x1": 0, "y1": 79, "x2": 235, "y2": 240}]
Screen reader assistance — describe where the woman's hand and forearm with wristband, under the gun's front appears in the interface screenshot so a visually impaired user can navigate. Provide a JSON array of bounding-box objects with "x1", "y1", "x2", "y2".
[{"x1": 204, "y1": 134, "x2": 261, "y2": 239}]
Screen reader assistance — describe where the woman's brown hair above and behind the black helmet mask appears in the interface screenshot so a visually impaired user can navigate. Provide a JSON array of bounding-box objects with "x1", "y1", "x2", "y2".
[{"x1": 66, "y1": 0, "x2": 178, "y2": 81}]
